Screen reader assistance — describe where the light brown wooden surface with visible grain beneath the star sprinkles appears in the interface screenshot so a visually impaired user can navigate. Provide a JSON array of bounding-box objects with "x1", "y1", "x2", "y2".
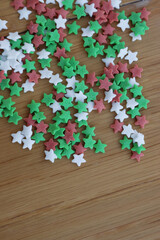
[{"x1": 0, "y1": 0, "x2": 160, "y2": 240}]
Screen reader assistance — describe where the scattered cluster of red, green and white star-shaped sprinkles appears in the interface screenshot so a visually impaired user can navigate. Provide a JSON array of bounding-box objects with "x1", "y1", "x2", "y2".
[{"x1": 0, "y1": 0, "x2": 150, "y2": 166}]
